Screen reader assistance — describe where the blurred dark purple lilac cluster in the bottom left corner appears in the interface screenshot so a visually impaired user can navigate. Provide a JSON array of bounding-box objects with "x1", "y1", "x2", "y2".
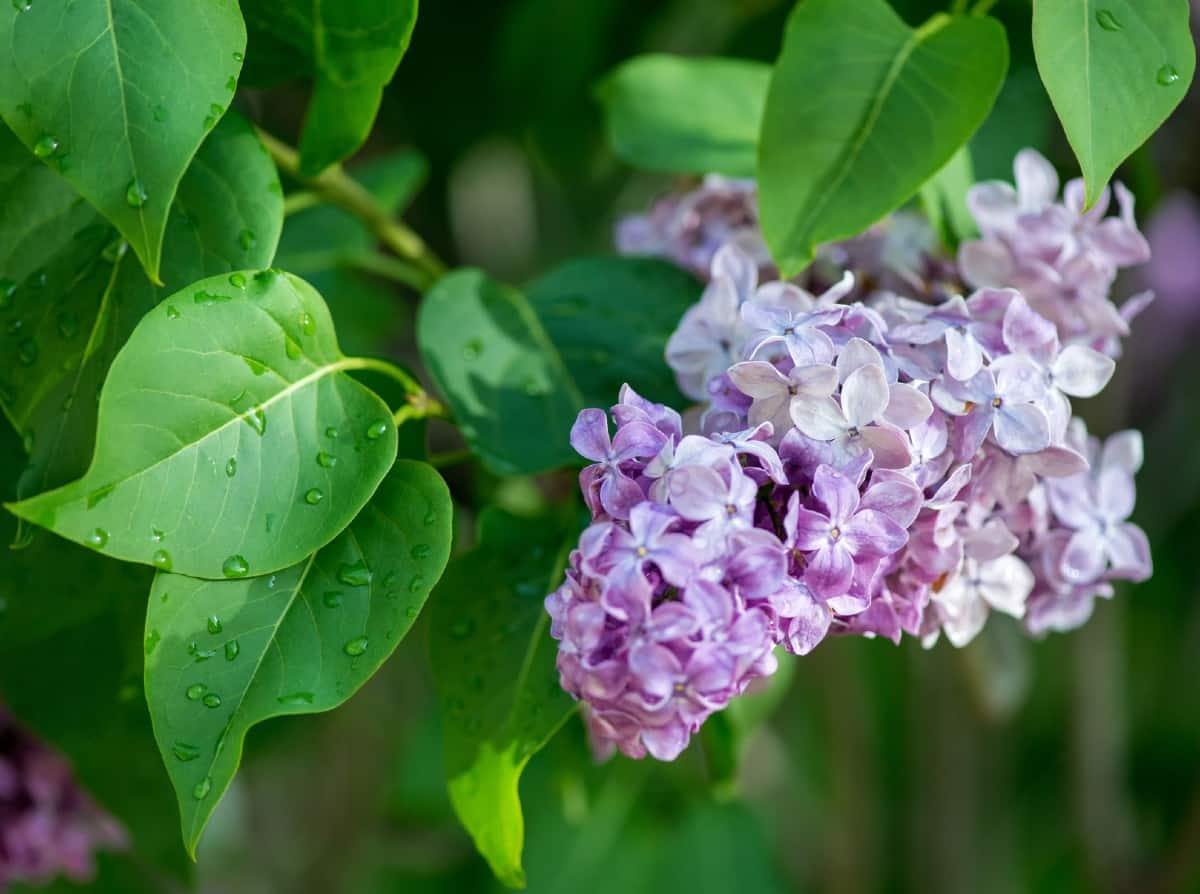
[{"x1": 0, "y1": 709, "x2": 126, "y2": 890}]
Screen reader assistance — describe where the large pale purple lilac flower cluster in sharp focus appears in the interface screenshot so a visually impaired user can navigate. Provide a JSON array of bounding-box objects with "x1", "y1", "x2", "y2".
[{"x1": 546, "y1": 150, "x2": 1151, "y2": 760}]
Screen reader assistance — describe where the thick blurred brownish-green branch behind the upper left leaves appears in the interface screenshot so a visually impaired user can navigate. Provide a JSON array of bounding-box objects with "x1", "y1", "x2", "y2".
[{"x1": 256, "y1": 127, "x2": 446, "y2": 288}]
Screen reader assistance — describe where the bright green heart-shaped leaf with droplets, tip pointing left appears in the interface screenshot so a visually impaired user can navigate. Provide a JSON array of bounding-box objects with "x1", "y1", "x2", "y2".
[{"x1": 10, "y1": 270, "x2": 396, "y2": 580}]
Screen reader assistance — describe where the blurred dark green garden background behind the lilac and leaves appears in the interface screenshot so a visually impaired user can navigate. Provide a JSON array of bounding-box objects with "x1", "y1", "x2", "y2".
[{"x1": 182, "y1": 0, "x2": 1200, "y2": 894}]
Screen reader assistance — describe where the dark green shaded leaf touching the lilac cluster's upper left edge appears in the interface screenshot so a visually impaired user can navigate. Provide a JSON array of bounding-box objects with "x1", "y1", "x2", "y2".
[{"x1": 526, "y1": 258, "x2": 702, "y2": 407}]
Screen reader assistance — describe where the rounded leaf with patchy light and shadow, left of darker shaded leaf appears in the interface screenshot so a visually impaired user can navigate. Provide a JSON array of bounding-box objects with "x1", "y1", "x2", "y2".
[{"x1": 416, "y1": 270, "x2": 583, "y2": 475}]
